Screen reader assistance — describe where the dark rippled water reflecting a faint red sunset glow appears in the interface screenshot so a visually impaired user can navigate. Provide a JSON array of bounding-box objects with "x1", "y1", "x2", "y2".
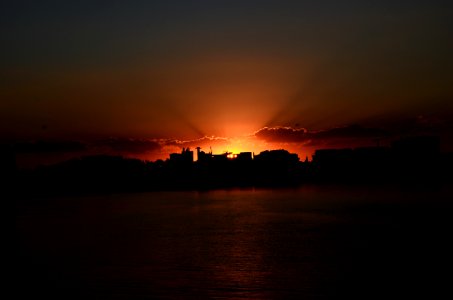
[{"x1": 14, "y1": 187, "x2": 453, "y2": 299}]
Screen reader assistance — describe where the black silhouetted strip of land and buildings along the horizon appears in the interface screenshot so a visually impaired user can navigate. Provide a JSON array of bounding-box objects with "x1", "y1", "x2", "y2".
[{"x1": 1, "y1": 136, "x2": 453, "y2": 195}]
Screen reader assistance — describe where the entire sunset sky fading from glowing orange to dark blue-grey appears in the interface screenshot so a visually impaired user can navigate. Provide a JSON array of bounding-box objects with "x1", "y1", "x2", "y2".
[{"x1": 0, "y1": 0, "x2": 453, "y2": 164}]
